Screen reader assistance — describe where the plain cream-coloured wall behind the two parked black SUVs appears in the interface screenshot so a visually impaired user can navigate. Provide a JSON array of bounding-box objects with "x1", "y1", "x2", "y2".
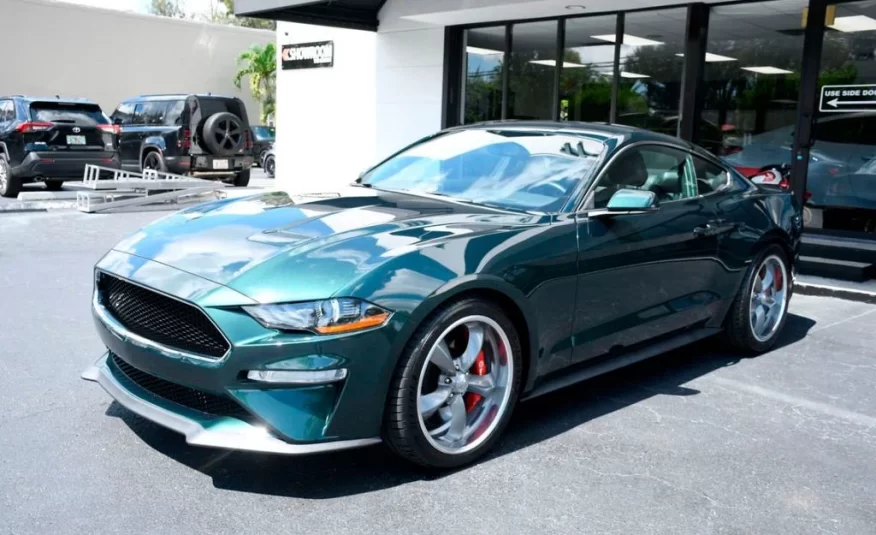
[{"x1": 0, "y1": 0, "x2": 275, "y2": 122}]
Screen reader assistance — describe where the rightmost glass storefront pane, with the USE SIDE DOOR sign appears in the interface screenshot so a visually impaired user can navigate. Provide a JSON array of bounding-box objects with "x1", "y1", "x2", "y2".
[{"x1": 805, "y1": 1, "x2": 876, "y2": 236}]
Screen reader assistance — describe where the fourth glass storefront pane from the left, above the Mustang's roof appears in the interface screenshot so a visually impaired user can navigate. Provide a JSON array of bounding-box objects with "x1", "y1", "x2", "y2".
[{"x1": 612, "y1": 8, "x2": 687, "y2": 136}]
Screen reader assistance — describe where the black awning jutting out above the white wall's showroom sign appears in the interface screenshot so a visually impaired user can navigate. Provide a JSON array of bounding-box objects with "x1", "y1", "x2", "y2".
[{"x1": 234, "y1": 0, "x2": 386, "y2": 31}]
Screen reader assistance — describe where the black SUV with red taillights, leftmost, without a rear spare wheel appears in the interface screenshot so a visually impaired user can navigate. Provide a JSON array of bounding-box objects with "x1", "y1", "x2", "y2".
[{"x1": 0, "y1": 95, "x2": 119, "y2": 197}]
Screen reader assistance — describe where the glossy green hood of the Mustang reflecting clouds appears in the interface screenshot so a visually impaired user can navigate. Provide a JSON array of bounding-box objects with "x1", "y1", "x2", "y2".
[{"x1": 114, "y1": 187, "x2": 536, "y2": 302}]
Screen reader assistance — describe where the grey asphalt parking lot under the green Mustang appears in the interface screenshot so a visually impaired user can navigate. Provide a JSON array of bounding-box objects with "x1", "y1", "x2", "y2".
[{"x1": 0, "y1": 208, "x2": 876, "y2": 535}]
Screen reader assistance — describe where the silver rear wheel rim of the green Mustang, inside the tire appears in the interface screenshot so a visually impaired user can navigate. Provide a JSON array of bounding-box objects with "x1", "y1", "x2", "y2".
[{"x1": 749, "y1": 255, "x2": 790, "y2": 342}]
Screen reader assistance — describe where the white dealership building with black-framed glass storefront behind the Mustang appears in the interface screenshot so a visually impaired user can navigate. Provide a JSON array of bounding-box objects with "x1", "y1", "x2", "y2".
[{"x1": 235, "y1": 0, "x2": 876, "y2": 280}]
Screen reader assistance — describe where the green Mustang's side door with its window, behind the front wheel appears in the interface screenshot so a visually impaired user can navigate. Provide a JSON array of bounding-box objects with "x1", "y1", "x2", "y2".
[{"x1": 572, "y1": 144, "x2": 718, "y2": 362}]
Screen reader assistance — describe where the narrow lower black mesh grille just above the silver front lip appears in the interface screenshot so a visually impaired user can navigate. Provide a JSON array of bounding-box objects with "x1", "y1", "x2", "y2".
[{"x1": 110, "y1": 353, "x2": 253, "y2": 420}]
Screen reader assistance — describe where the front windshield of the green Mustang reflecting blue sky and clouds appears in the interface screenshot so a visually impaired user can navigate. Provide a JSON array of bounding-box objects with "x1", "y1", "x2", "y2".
[{"x1": 361, "y1": 129, "x2": 605, "y2": 212}]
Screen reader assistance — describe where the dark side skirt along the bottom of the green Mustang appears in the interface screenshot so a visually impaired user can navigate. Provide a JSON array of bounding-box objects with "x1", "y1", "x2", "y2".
[{"x1": 522, "y1": 328, "x2": 722, "y2": 401}]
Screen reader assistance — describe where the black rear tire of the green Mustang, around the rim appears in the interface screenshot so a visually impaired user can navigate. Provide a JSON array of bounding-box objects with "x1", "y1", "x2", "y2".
[{"x1": 724, "y1": 245, "x2": 793, "y2": 354}]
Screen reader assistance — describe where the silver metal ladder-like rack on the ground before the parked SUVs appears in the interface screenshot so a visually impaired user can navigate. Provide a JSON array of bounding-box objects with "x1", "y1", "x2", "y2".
[{"x1": 71, "y1": 164, "x2": 228, "y2": 213}]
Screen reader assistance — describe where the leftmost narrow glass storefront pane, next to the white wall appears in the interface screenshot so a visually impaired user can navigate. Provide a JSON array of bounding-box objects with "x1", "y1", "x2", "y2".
[{"x1": 462, "y1": 26, "x2": 505, "y2": 124}]
